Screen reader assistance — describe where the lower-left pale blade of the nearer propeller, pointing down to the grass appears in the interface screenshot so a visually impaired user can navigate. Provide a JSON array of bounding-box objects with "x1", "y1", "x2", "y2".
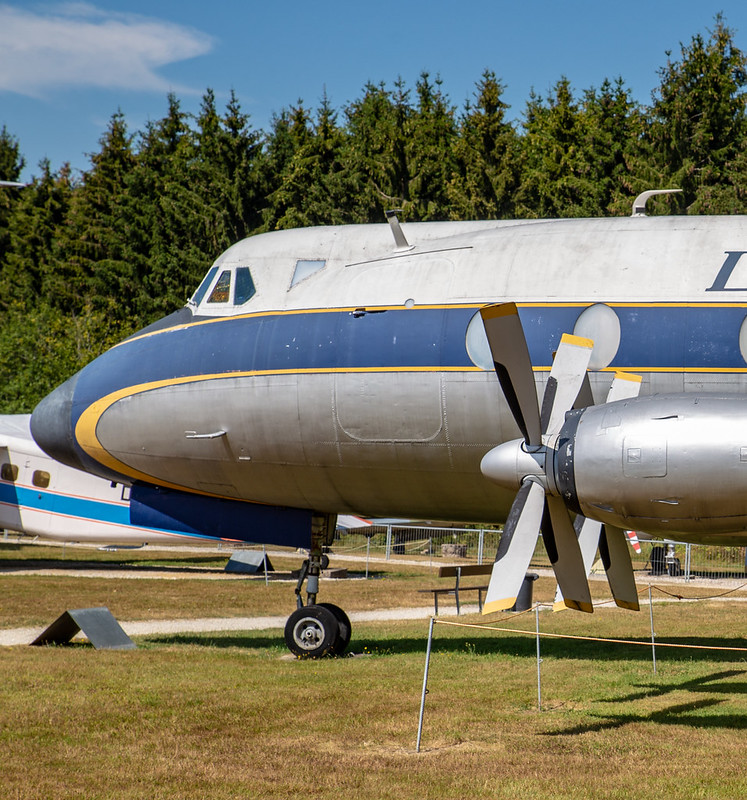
[{"x1": 482, "y1": 481, "x2": 545, "y2": 614}]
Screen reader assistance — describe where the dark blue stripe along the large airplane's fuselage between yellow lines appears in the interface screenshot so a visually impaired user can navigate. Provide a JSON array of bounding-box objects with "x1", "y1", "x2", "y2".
[{"x1": 72, "y1": 304, "x2": 747, "y2": 425}]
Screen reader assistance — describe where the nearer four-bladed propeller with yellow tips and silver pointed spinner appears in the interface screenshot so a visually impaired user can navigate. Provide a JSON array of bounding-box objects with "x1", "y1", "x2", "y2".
[{"x1": 480, "y1": 303, "x2": 594, "y2": 614}]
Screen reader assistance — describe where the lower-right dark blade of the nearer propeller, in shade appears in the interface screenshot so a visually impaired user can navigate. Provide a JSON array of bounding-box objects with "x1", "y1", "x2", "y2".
[{"x1": 542, "y1": 495, "x2": 594, "y2": 614}]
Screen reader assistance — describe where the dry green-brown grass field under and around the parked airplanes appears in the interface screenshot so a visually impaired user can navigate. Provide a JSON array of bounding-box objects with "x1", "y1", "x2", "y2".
[{"x1": 0, "y1": 547, "x2": 747, "y2": 800}]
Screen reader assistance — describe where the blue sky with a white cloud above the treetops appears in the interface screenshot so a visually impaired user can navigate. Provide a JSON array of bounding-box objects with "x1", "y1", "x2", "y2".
[{"x1": 0, "y1": 0, "x2": 747, "y2": 179}]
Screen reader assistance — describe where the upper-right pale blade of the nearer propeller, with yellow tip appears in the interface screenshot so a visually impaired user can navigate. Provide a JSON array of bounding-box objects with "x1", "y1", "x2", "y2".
[{"x1": 540, "y1": 333, "x2": 594, "y2": 435}]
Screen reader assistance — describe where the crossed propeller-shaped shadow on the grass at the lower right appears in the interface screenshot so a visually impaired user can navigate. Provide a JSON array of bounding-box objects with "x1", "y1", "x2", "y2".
[{"x1": 542, "y1": 670, "x2": 747, "y2": 736}]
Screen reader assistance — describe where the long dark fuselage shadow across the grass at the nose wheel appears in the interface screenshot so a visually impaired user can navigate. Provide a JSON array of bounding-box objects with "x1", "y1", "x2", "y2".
[{"x1": 142, "y1": 630, "x2": 747, "y2": 663}]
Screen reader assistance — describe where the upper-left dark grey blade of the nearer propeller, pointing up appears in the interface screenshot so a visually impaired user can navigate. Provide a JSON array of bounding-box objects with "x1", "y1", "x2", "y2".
[{"x1": 480, "y1": 303, "x2": 542, "y2": 445}]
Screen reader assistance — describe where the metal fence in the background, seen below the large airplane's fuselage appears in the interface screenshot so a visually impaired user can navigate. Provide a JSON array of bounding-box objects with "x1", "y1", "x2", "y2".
[{"x1": 332, "y1": 525, "x2": 747, "y2": 581}]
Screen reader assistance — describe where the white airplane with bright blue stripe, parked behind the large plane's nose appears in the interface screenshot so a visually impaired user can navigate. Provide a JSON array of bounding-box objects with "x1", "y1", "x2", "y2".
[{"x1": 0, "y1": 414, "x2": 264, "y2": 547}]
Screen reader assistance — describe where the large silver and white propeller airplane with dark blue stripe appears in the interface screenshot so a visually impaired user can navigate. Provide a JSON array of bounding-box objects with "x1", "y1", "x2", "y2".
[{"x1": 31, "y1": 192, "x2": 747, "y2": 656}]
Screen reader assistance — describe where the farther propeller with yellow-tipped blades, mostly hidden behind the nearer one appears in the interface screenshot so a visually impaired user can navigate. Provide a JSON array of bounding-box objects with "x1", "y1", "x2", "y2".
[{"x1": 553, "y1": 372, "x2": 641, "y2": 611}]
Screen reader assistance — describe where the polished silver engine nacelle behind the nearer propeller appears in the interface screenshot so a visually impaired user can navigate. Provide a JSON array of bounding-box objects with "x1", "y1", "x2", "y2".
[{"x1": 560, "y1": 394, "x2": 747, "y2": 543}]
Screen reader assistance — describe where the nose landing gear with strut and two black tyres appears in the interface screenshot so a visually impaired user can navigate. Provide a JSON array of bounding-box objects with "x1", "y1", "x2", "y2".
[{"x1": 285, "y1": 514, "x2": 351, "y2": 658}]
